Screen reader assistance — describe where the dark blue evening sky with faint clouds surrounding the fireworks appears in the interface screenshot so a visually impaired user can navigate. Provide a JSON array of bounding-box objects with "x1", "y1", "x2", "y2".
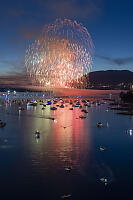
[{"x1": 0, "y1": 0, "x2": 133, "y2": 75}]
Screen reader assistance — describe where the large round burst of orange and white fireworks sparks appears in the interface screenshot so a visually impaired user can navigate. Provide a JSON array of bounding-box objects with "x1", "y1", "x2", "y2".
[{"x1": 25, "y1": 19, "x2": 94, "y2": 88}]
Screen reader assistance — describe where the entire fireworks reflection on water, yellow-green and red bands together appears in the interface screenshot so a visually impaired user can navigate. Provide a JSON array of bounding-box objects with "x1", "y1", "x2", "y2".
[{"x1": 22, "y1": 103, "x2": 91, "y2": 177}]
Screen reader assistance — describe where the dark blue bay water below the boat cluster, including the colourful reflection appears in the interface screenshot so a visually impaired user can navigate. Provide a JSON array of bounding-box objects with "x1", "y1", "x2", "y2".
[{"x1": 0, "y1": 93, "x2": 133, "y2": 200}]
